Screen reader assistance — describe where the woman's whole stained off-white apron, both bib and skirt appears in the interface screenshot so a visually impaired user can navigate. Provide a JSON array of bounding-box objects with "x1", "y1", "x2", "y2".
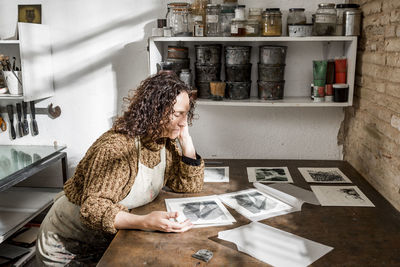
[{"x1": 36, "y1": 139, "x2": 166, "y2": 266}]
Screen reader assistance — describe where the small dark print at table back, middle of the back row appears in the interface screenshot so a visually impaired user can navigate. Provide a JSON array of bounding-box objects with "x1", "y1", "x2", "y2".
[{"x1": 247, "y1": 167, "x2": 293, "y2": 183}]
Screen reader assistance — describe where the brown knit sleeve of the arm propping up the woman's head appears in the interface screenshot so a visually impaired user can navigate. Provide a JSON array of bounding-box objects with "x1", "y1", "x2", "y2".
[{"x1": 166, "y1": 139, "x2": 204, "y2": 193}]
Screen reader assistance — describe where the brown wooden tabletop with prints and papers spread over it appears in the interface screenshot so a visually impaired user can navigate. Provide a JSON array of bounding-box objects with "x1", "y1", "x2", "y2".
[{"x1": 98, "y1": 159, "x2": 400, "y2": 267}]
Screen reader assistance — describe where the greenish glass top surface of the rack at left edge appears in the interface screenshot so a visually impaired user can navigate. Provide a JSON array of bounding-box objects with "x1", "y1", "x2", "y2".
[{"x1": 0, "y1": 187, "x2": 62, "y2": 243}]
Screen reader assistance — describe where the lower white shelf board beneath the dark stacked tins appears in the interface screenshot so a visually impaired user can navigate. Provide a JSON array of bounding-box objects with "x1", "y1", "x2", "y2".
[{"x1": 196, "y1": 97, "x2": 351, "y2": 107}]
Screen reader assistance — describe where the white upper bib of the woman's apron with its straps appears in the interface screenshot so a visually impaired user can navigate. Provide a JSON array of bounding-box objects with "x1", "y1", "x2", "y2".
[{"x1": 119, "y1": 139, "x2": 166, "y2": 209}]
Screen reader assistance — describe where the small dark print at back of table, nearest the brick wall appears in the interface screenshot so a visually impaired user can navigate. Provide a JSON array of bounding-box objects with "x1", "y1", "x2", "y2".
[{"x1": 299, "y1": 168, "x2": 351, "y2": 183}]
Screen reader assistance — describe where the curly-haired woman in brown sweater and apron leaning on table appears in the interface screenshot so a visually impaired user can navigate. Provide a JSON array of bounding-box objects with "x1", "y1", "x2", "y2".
[{"x1": 36, "y1": 72, "x2": 204, "y2": 266}]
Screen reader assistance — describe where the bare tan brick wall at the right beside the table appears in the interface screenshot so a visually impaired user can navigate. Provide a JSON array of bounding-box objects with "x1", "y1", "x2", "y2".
[{"x1": 338, "y1": 0, "x2": 400, "y2": 210}]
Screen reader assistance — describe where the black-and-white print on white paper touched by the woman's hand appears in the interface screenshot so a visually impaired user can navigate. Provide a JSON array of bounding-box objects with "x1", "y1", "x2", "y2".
[{"x1": 165, "y1": 195, "x2": 236, "y2": 228}]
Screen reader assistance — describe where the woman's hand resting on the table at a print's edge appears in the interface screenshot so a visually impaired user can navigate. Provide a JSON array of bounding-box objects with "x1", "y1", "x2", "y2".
[{"x1": 142, "y1": 211, "x2": 193, "y2": 233}]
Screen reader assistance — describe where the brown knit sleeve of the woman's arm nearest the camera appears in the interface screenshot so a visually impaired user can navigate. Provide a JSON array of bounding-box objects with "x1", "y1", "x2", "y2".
[{"x1": 80, "y1": 144, "x2": 131, "y2": 234}]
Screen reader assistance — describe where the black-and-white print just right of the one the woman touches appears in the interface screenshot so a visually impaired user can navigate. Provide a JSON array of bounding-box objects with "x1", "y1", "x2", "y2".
[{"x1": 219, "y1": 189, "x2": 292, "y2": 220}]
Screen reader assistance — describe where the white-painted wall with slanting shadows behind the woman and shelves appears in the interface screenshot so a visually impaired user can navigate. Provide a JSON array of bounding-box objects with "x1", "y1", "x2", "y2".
[{"x1": 0, "y1": 0, "x2": 343, "y2": 187}]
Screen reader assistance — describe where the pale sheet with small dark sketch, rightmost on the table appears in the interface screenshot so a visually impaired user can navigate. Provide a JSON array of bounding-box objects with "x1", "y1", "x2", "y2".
[{"x1": 311, "y1": 185, "x2": 375, "y2": 207}]
